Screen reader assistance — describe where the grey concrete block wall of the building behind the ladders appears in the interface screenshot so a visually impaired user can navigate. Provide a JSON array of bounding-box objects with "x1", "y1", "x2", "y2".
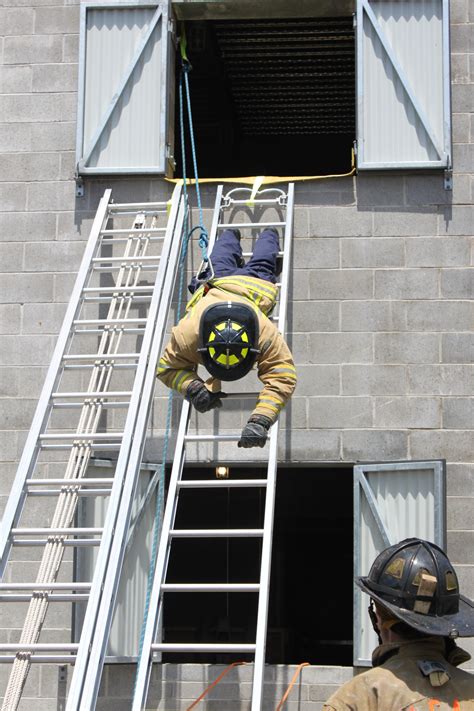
[{"x1": 0, "y1": 0, "x2": 474, "y2": 711}]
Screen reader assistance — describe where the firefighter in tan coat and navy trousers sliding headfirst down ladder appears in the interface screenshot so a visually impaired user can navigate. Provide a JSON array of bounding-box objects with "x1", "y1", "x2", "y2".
[{"x1": 157, "y1": 229, "x2": 296, "y2": 447}]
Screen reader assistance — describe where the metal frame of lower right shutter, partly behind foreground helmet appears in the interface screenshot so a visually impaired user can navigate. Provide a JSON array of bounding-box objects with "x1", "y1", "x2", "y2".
[{"x1": 353, "y1": 459, "x2": 446, "y2": 667}]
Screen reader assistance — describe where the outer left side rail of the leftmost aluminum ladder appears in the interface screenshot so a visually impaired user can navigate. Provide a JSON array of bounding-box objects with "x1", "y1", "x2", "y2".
[{"x1": 0, "y1": 190, "x2": 112, "y2": 578}]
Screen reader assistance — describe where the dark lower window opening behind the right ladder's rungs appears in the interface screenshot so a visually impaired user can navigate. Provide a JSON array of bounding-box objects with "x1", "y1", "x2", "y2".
[{"x1": 163, "y1": 467, "x2": 353, "y2": 666}]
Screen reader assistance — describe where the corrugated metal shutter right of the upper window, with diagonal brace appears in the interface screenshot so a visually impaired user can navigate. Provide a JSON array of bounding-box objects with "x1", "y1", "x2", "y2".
[{"x1": 357, "y1": 0, "x2": 450, "y2": 168}]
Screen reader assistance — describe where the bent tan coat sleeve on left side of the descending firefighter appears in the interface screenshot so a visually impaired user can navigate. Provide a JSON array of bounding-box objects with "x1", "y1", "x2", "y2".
[{"x1": 156, "y1": 324, "x2": 202, "y2": 395}]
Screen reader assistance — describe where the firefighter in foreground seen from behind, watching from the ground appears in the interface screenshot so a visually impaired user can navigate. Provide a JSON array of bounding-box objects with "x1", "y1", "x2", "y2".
[{"x1": 323, "y1": 538, "x2": 474, "y2": 711}]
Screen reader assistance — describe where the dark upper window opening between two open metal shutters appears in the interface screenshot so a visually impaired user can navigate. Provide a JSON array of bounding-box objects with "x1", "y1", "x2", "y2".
[{"x1": 175, "y1": 17, "x2": 355, "y2": 178}]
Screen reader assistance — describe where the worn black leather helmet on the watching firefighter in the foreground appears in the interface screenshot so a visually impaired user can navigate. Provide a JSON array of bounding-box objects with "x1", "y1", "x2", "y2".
[{"x1": 355, "y1": 538, "x2": 474, "y2": 639}]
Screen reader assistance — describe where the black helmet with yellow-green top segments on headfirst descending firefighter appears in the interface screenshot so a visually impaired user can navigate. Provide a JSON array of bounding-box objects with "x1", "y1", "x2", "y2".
[{"x1": 198, "y1": 301, "x2": 259, "y2": 380}]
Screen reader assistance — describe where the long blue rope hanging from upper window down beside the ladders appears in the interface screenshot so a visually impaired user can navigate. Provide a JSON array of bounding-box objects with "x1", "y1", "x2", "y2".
[{"x1": 134, "y1": 52, "x2": 196, "y2": 695}]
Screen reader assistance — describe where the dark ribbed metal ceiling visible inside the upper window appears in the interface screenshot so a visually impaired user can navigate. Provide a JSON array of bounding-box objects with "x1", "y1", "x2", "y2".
[{"x1": 214, "y1": 17, "x2": 355, "y2": 136}]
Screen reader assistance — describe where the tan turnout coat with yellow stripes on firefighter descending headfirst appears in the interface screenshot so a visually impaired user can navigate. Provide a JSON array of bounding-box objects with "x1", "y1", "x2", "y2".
[{"x1": 157, "y1": 275, "x2": 296, "y2": 422}]
